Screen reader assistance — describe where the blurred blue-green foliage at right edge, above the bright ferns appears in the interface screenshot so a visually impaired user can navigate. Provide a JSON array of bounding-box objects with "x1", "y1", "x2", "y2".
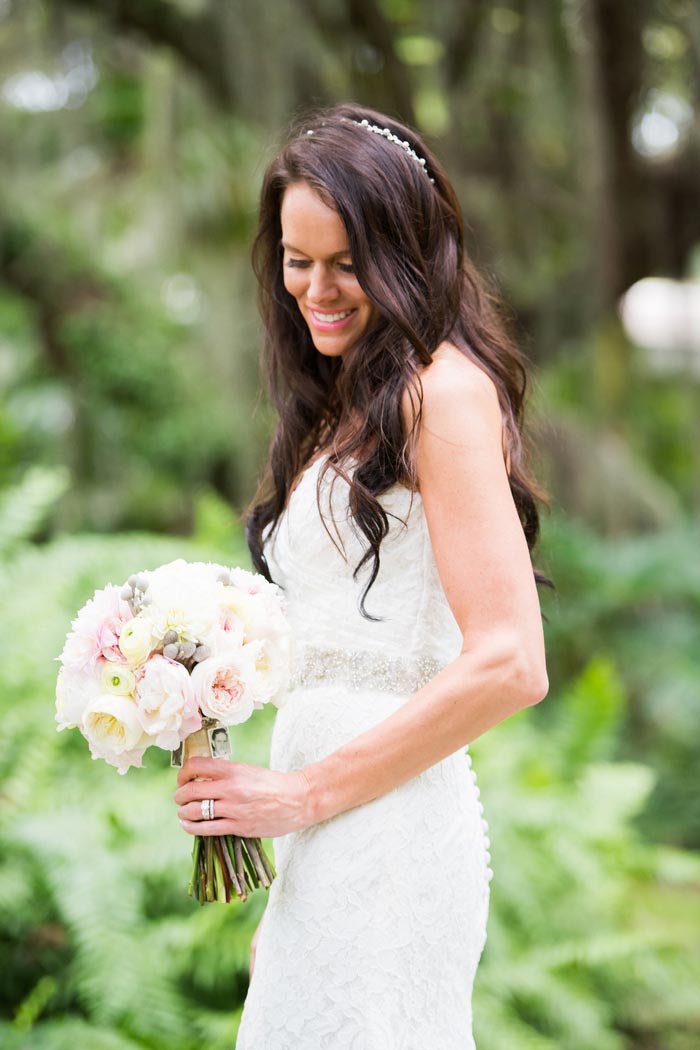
[{"x1": 543, "y1": 515, "x2": 700, "y2": 848}]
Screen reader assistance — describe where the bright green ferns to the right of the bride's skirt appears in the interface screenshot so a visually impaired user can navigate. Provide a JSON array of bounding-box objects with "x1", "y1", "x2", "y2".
[{"x1": 471, "y1": 657, "x2": 700, "y2": 1050}]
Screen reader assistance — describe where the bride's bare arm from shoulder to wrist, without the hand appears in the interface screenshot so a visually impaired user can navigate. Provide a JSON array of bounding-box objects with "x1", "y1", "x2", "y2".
[{"x1": 302, "y1": 357, "x2": 548, "y2": 823}]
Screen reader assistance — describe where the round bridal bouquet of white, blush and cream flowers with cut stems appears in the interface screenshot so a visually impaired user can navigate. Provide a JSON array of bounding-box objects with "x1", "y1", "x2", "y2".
[{"x1": 56, "y1": 559, "x2": 292, "y2": 904}]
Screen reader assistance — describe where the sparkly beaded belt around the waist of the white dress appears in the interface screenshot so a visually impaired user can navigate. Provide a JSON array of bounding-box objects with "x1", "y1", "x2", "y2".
[{"x1": 290, "y1": 646, "x2": 443, "y2": 693}]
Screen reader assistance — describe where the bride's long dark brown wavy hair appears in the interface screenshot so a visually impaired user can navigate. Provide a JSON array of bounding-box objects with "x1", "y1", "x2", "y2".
[{"x1": 246, "y1": 103, "x2": 549, "y2": 620}]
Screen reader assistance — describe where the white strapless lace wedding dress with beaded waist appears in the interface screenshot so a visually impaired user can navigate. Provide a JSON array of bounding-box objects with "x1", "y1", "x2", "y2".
[{"x1": 236, "y1": 459, "x2": 492, "y2": 1050}]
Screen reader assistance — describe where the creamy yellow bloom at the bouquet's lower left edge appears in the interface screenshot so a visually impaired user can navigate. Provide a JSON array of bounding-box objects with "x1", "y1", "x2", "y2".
[{"x1": 81, "y1": 693, "x2": 152, "y2": 773}]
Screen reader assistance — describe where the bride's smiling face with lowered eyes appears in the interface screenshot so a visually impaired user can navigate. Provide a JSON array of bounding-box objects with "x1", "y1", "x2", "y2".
[{"x1": 280, "y1": 183, "x2": 375, "y2": 357}]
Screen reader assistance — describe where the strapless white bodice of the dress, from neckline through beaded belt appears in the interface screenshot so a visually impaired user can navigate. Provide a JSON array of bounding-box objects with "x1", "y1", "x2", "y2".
[{"x1": 263, "y1": 458, "x2": 463, "y2": 691}]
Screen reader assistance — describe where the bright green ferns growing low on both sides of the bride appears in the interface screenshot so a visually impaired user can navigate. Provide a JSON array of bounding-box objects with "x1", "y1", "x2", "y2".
[{"x1": 0, "y1": 520, "x2": 700, "y2": 1050}]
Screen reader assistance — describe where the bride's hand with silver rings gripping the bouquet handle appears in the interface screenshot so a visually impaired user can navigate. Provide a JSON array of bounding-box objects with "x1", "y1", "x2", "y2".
[{"x1": 174, "y1": 757, "x2": 315, "y2": 839}]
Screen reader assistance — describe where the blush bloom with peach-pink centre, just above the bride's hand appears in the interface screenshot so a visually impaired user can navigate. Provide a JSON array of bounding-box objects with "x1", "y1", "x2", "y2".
[{"x1": 191, "y1": 650, "x2": 255, "y2": 726}]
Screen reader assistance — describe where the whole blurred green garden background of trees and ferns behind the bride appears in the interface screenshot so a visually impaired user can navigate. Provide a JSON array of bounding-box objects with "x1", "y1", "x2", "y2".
[{"x1": 0, "y1": 0, "x2": 700, "y2": 1050}]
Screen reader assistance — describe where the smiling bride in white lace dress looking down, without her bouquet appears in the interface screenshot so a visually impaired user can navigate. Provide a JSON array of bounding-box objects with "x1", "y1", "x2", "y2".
[{"x1": 175, "y1": 104, "x2": 548, "y2": 1050}]
